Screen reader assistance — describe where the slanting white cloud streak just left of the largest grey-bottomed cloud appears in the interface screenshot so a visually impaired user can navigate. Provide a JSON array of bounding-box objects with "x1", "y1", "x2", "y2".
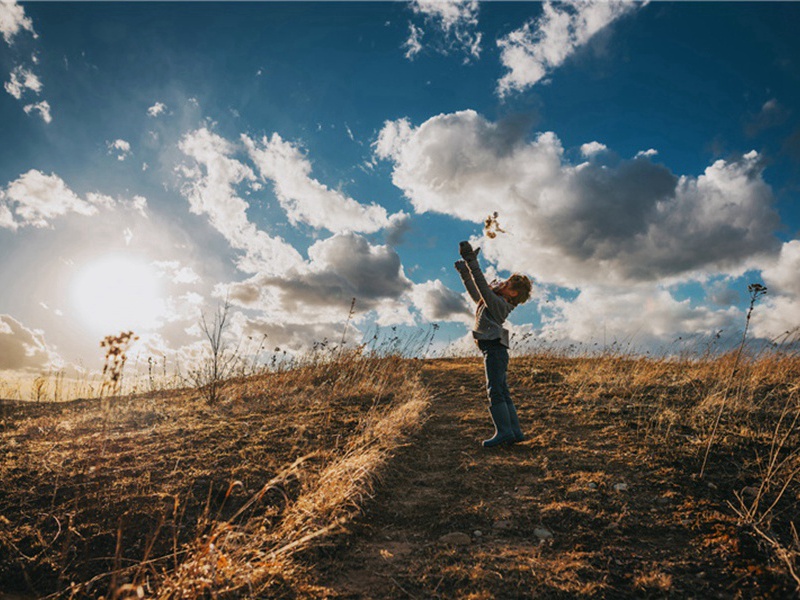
[{"x1": 242, "y1": 133, "x2": 390, "y2": 233}]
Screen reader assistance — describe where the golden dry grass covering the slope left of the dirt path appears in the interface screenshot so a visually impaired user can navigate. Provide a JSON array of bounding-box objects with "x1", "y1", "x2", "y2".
[{"x1": 0, "y1": 351, "x2": 432, "y2": 598}]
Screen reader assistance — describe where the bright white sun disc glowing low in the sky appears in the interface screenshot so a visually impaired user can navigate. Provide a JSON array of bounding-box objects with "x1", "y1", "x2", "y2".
[{"x1": 71, "y1": 256, "x2": 165, "y2": 335}]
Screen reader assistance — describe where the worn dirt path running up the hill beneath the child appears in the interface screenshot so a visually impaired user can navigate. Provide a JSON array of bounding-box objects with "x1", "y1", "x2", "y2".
[{"x1": 316, "y1": 360, "x2": 785, "y2": 598}]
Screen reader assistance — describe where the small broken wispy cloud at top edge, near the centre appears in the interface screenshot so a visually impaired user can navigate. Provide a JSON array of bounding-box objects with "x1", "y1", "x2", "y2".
[{"x1": 403, "y1": 0, "x2": 481, "y2": 60}]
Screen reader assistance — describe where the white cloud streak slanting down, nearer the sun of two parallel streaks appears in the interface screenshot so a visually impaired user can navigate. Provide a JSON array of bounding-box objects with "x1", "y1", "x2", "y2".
[{"x1": 179, "y1": 128, "x2": 302, "y2": 274}]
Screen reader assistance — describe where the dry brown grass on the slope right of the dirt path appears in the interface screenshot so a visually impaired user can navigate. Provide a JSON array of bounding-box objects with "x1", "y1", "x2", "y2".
[{"x1": 520, "y1": 350, "x2": 800, "y2": 591}]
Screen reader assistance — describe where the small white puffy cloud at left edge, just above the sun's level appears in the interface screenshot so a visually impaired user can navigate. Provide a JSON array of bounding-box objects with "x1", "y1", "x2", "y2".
[{"x1": 0, "y1": 169, "x2": 113, "y2": 229}]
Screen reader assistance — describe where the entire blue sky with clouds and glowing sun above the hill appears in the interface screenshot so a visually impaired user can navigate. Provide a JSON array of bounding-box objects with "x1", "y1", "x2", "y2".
[{"x1": 0, "y1": 0, "x2": 800, "y2": 384}]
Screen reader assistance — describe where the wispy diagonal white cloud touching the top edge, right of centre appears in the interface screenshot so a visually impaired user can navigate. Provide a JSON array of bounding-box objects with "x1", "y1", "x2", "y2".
[{"x1": 497, "y1": 0, "x2": 638, "y2": 96}]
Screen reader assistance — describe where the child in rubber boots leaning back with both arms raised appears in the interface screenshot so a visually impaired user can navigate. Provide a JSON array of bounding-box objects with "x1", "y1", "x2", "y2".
[{"x1": 455, "y1": 242, "x2": 531, "y2": 448}]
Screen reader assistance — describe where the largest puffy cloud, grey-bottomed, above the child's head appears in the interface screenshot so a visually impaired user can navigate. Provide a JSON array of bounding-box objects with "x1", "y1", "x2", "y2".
[{"x1": 375, "y1": 111, "x2": 780, "y2": 287}]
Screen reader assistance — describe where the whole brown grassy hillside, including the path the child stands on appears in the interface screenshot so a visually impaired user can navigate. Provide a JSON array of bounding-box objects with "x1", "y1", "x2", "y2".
[{"x1": 0, "y1": 356, "x2": 800, "y2": 598}]
